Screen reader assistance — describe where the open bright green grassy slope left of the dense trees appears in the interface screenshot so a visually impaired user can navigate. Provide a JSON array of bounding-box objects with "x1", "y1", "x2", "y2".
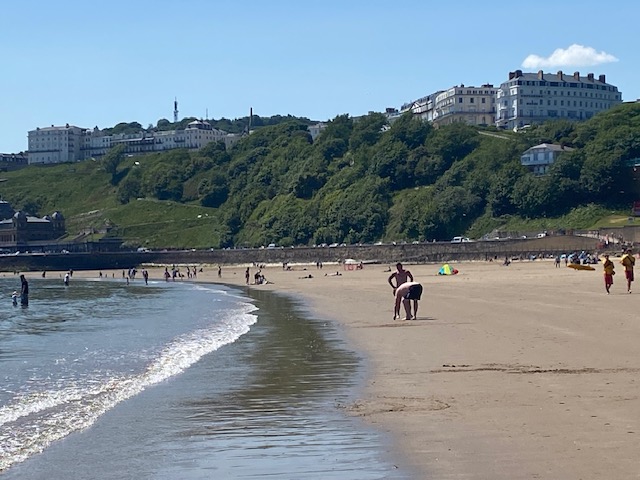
[{"x1": 0, "y1": 161, "x2": 225, "y2": 248}]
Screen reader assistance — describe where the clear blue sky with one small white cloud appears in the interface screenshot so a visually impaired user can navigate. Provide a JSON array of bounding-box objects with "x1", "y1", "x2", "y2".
[{"x1": 0, "y1": 0, "x2": 640, "y2": 153}]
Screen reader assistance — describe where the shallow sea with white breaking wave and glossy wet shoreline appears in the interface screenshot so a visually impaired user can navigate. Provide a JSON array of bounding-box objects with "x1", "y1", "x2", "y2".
[{"x1": 0, "y1": 273, "x2": 411, "y2": 480}]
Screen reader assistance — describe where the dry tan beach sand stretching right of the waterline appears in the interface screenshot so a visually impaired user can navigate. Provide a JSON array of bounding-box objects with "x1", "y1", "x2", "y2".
[{"x1": 63, "y1": 259, "x2": 640, "y2": 480}]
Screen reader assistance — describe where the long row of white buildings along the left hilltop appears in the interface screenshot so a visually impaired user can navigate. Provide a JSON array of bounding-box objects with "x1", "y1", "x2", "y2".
[{"x1": 27, "y1": 120, "x2": 240, "y2": 165}]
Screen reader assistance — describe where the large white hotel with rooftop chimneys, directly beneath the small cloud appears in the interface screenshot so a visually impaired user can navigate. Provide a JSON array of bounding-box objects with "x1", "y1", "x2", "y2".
[{"x1": 496, "y1": 70, "x2": 622, "y2": 129}]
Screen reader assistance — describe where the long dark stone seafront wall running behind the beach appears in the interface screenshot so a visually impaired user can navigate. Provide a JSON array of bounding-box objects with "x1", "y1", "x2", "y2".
[{"x1": 0, "y1": 235, "x2": 604, "y2": 271}]
